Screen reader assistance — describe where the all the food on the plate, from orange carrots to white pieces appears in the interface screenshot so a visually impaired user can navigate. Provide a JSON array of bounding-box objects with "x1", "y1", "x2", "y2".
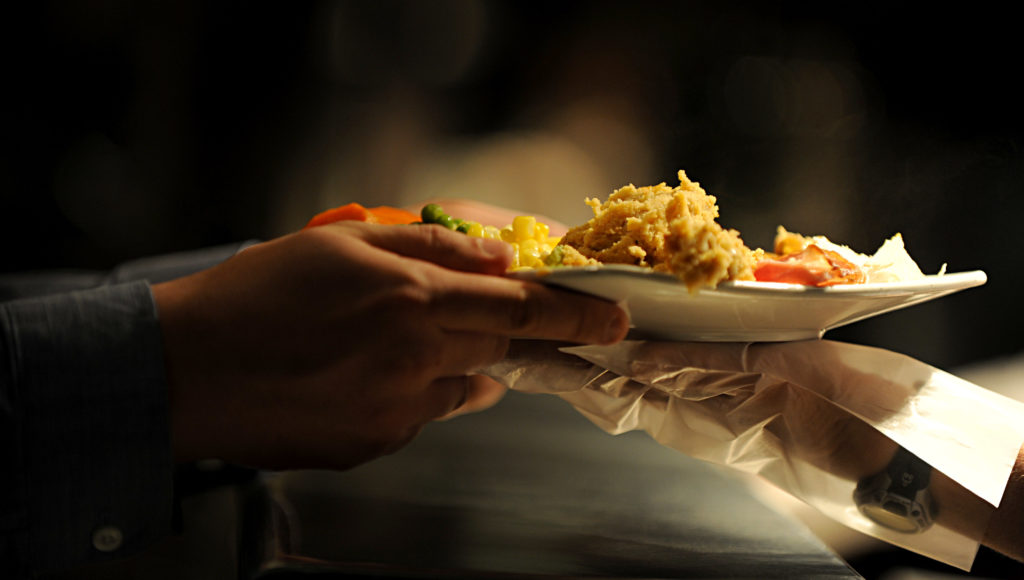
[{"x1": 306, "y1": 171, "x2": 929, "y2": 291}]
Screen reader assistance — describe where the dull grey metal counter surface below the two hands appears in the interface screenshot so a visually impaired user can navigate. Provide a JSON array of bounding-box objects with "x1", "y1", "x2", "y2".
[{"x1": 250, "y1": 392, "x2": 860, "y2": 579}]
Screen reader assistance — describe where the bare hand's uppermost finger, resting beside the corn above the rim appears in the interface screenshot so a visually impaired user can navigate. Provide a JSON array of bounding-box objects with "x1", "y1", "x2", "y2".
[{"x1": 336, "y1": 223, "x2": 512, "y2": 275}]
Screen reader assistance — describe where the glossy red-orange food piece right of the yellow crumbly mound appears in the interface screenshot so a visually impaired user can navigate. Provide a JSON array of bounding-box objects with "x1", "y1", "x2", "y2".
[{"x1": 754, "y1": 244, "x2": 866, "y2": 287}]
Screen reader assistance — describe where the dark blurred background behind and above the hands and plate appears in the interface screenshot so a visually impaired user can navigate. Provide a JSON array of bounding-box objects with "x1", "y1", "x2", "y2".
[{"x1": 0, "y1": 0, "x2": 1024, "y2": 368}]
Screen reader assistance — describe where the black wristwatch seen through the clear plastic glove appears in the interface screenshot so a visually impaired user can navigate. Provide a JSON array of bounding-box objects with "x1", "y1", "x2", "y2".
[{"x1": 853, "y1": 447, "x2": 936, "y2": 534}]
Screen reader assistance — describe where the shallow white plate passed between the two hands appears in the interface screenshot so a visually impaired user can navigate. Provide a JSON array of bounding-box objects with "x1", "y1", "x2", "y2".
[{"x1": 512, "y1": 264, "x2": 986, "y2": 342}]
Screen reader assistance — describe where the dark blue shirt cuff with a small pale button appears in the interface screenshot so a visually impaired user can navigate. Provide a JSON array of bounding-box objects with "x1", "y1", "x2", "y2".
[{"x1": 0, "y1": 282, "x2": 174, "y2": 573}]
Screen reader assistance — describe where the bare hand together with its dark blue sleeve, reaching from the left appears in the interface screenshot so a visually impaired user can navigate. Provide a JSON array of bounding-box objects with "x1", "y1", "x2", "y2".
[{"x1": 0, "y1": 219, "x2": 628, "y2": 574}]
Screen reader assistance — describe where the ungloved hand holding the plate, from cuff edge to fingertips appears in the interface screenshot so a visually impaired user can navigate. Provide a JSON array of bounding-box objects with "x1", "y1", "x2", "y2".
[{"x1": 153, "y1": 222, "x2": 628, "y2": 468}]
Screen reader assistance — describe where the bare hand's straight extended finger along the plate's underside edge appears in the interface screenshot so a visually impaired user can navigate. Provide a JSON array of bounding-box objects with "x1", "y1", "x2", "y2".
[{"x1": 432, "y1": 275, "x2": 629, "y2": 344}]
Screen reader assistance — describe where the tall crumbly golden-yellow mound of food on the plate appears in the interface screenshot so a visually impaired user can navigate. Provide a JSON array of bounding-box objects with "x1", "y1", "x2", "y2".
[{"x1": 561, "y1": 171, "x2": 760, "y2": 291}]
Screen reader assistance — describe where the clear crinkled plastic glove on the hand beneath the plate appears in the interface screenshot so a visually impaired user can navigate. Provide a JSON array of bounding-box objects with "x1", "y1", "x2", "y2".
[{"x1": 486, "y1": 340, "x2": 1024, "y2": 569}]
